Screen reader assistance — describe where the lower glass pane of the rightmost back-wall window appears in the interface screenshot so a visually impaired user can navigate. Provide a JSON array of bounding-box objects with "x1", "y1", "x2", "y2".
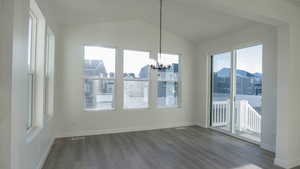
[{"x1": 157, "y1": 81, "x2": 178, "y2": 107}]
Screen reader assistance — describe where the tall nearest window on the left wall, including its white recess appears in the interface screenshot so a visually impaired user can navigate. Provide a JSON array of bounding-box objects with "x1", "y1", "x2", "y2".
[{"x1": 26, "y1": 0, "x2": 46, "y2": 132}]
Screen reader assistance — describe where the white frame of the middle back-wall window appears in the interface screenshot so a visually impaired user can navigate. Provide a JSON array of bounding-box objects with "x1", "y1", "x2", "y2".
[{"x1": 121, "y1": 48, "x2": 152, "y2": 110}]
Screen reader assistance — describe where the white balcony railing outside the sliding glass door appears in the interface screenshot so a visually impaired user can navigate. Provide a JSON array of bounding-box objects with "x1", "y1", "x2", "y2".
[{"x1": 212, "y1": 100, "x2": 261, "y2": 134}]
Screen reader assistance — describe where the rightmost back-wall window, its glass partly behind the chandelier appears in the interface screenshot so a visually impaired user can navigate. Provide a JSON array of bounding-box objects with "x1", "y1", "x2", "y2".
[{"x1": 157, "y1": 54, "x2": 180, "y2": 107}]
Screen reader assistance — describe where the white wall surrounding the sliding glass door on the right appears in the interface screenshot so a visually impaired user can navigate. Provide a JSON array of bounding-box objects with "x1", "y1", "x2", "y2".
[{"x1": 197, "y1": 25, "x2": 277, "y2": 151}]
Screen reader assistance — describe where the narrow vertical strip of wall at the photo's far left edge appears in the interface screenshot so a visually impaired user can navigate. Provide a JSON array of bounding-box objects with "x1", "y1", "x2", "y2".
[{"x1": 0, "y1": 0, "x2": 13, "y2": 169}]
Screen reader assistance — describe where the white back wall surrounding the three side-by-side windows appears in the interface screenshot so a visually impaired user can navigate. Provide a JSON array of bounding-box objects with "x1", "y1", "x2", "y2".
[{"x1": 56, "y1": 21, "x2": 196, "y2": 136}]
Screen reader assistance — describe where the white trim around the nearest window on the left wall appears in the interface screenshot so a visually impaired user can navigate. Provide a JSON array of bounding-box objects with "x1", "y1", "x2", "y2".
[{"x1": 26, "y1": 0, "x2": 46, "y2": 142}]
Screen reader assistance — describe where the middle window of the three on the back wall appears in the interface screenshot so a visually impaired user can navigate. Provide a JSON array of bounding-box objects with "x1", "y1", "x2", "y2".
[{"x1": 123, "y1": 50, "x2": 150, "y2": 109}]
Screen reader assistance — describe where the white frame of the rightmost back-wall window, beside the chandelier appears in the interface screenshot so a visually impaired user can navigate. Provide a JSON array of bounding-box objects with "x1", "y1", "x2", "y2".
[{"x1": 155, "y1": 52, "x2": 182, "y2": 109}]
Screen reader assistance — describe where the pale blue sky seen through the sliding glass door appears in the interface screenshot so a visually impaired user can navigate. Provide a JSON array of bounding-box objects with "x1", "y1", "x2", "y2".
[{"x1": 214, "y1": 45, "x2": 263, "y2": 73}]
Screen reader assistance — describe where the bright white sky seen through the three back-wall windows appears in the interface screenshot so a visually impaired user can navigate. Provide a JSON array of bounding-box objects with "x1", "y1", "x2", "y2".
[{"x1": 84, "y1": 46, "x2": 179, "y2": 77}]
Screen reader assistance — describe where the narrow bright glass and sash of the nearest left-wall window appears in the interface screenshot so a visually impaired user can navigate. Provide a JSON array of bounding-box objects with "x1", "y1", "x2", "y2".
[{"x1": 27, "y1": 12, "x2": 37, "y2": 130}]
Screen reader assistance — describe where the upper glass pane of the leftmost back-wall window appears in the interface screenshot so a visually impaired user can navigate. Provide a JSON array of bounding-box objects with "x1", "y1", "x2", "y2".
[{"x1": 84, "y1": 46, "x2": 116, "y2": 78}]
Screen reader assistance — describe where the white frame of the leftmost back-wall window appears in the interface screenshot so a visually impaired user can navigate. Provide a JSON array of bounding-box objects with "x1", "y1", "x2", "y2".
[{"x1": 82, "y1": 44, "x2": 118, "y2": 112}]
